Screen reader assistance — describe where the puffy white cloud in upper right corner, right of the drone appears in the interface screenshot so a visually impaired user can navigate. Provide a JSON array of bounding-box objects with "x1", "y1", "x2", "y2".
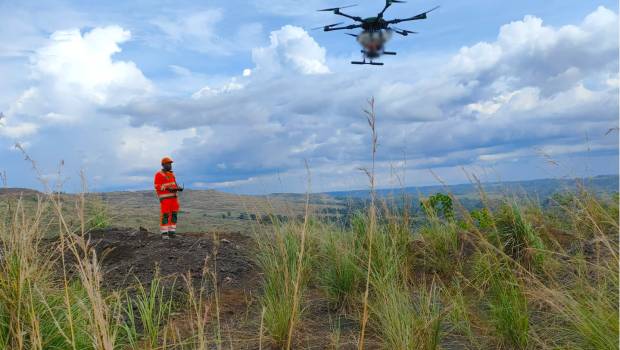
[{"x1": 449, "y1": 7, "x2": 618, "y2": 90}]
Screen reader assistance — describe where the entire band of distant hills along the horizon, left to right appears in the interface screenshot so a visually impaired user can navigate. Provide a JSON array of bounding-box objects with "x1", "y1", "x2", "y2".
[{"x1": 0, "y1": 175, "x2": 618, "y2": 233}]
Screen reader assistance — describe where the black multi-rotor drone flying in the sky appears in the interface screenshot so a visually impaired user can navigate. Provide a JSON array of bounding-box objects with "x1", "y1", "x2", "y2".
[{"x1": 313, "y1": 0, "x2": 439, "y2": 66}]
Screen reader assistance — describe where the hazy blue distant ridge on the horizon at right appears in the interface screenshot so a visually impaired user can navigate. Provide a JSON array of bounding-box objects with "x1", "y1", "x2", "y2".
[{"x1": 325, "y1": 175, "x2": 618, "y2": 199}]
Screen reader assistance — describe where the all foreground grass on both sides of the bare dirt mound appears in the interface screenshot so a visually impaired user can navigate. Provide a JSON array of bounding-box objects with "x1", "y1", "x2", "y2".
[{"x1": 0, "y1": 140, "x2": 620, "y2": 350}]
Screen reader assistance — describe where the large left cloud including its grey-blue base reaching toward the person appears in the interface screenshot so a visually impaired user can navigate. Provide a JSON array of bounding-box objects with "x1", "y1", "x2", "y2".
[{"x1": 0, "y1": 26, "x2": 195, "y2": 186}]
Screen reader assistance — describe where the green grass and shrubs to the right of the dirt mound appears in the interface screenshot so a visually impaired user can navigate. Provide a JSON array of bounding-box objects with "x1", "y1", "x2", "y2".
[{"x1": 254, "y1": 186, "x2": 618, "y2": 349}]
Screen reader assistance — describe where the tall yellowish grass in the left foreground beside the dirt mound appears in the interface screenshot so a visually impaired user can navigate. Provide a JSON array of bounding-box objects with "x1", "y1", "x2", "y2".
[{"x1": 0, "y1": 155, "x2": 218, "y2": 350}]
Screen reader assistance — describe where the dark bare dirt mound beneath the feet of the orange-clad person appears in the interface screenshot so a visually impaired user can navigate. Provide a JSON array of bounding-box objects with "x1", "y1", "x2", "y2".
[{"x1": 73, "y1": 228, "x2": 256, "y2": 290}]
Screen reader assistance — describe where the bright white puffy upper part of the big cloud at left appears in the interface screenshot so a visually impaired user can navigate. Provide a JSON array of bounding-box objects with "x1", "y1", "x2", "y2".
[{"x1": 0, "y1": 26, "x2": 153, "y2": 139}]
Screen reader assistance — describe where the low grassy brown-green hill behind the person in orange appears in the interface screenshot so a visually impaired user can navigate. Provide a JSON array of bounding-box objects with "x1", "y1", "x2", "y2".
[{"x1": 0, "y1": 188, "x2": 344, "y2": 233}]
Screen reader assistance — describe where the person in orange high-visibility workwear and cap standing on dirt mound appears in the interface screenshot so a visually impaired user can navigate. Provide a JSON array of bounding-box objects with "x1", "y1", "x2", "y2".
[{"x1": 154, "y1": 157, "x2": 183, "y2": 239}]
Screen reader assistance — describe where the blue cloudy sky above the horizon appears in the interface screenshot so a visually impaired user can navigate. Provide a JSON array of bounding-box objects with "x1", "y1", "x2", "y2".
[{"x1": 0, "y1": 0, "x2": 619, "y2": 194}]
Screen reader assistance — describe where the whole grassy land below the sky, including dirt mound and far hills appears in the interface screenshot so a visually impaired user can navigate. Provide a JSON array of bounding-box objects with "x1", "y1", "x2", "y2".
[{"x1": 0, "y1": 176, "x2": 618, "y2": 349}]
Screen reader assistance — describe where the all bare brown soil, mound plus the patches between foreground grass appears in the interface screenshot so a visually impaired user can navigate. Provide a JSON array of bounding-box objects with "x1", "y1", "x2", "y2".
[{"x1": 50, "y1": 228, "x2": 368, "y2": 349}]
